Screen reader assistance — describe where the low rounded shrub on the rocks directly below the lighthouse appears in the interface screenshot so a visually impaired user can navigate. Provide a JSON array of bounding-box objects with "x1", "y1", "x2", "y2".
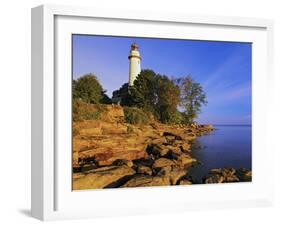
[{"x1": 124, "y1": 107, "x2": 151, "y2": 124}]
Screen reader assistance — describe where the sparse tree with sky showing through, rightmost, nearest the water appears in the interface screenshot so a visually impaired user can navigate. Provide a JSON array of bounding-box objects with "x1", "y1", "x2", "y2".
[{"x1": 175, "y1": 76, "x2": 208, "y2": 124}]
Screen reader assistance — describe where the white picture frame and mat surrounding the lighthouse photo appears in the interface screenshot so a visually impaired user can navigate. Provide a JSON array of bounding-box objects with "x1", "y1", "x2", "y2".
[{"x1": 31, "y1": 5, "x2": 274, "y2": 220}]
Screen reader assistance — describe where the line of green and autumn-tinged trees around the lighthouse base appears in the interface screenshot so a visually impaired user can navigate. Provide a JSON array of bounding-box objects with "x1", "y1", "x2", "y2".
[{"x1": 73, "y1": 70, "x2": 207, "y2": 124}]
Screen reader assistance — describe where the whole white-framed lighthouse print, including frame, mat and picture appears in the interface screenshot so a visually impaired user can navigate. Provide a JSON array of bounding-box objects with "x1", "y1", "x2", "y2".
[{"x1": 32, "y1": 5, "x2": 273, "y2": 220}]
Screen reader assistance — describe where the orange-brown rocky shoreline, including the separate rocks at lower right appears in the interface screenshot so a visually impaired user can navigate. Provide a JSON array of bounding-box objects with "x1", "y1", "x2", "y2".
[{"x1": 73, "y1": 106, "x2": 251, "y2": 190}]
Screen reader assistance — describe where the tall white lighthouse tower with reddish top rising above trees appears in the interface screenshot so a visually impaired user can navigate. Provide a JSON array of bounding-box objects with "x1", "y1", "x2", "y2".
[{"x1": 128, "y1": 43, "x2": 141, "y2": 86}]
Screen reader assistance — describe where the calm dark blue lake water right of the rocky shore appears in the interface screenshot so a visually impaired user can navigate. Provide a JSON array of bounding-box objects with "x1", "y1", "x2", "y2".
[{"x1": 189, "y1": 125, "x2": 252, "y2": 183}]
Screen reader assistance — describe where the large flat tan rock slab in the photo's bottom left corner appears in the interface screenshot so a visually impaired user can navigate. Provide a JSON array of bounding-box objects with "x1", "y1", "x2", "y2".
[{"x1": 73, "y1": 165, "x2": 136, "y2": 190}]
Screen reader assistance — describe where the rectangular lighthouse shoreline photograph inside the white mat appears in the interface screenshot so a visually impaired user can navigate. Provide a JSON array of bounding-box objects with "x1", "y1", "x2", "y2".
[{"x1": 69, "y1": 34, "x2": 252, "y2": 190}]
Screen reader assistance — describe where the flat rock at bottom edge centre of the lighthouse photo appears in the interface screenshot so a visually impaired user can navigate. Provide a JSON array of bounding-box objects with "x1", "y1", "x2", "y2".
[{"x1": 122, "y1": 175, "x2": 170, "y2": 187}]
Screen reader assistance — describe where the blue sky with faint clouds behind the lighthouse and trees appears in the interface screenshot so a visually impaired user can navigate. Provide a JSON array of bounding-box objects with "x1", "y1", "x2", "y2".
[{"x1": 73, "y1": 35, "x2": 252, "y2": 124}]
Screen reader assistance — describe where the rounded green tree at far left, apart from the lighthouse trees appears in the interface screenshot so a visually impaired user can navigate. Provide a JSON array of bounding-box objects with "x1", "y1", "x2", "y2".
[{"x1": 72, "y1": 74, "x2": 108, "y2": 104}]
